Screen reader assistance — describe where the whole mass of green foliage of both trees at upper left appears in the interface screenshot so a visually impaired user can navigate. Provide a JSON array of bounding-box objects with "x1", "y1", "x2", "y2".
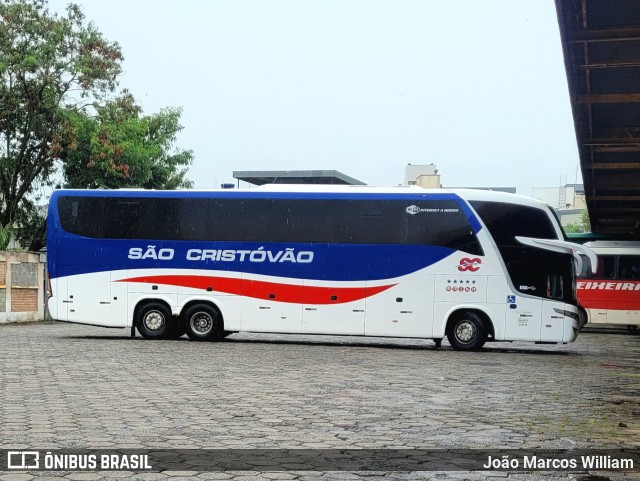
[{"x1": 0, "y1": 0, "x2": 193, "y2": 249}]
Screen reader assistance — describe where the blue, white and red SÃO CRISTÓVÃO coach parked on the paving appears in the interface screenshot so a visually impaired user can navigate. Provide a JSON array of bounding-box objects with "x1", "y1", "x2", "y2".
[{"x1": 47, "y1": 185, "x2": 593, "y2": 349}]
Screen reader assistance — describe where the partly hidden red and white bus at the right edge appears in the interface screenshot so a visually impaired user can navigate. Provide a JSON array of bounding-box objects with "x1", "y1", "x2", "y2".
[{"x1": 577, "y1": 240, "x2": 640, "y2": 329}]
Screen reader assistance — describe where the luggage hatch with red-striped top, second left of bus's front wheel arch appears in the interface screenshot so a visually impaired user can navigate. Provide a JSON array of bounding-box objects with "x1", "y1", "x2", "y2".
[{"x1": 302, "y1": 285, "x2": 365, "y2": 336}]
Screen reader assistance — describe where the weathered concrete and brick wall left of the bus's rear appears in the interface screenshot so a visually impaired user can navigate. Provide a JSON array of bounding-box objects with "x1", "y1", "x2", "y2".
[{"x1": 0, "y1": 252, "x2": 44, "y2": 323}]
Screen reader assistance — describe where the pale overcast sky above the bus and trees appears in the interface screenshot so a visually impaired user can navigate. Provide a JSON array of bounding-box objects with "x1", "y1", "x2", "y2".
[{"x1": 49, "y1": 0, "x2": 581, "y2": 195}]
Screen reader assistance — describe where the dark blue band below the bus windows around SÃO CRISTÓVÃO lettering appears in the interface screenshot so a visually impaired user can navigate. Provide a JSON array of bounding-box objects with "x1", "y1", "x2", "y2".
[{"x1": 49, "y1": 240, "x2": 457, "y2": 281}]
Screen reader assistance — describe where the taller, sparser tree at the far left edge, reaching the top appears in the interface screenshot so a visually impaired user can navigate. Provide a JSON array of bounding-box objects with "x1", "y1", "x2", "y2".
[{"x1": 0, "y1": 0, "x2": 123, "y2": 226}]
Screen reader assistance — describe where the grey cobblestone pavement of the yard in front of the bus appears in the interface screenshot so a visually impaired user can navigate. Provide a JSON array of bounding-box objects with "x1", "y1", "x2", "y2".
[{"x1": 0, "y1": 323, "x2": 640, "y2": 481}]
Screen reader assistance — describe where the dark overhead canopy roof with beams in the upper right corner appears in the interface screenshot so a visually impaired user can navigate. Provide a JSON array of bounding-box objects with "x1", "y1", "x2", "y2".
[{"x1": 555, "y1": 0, "x2": 640, "y2": 238}]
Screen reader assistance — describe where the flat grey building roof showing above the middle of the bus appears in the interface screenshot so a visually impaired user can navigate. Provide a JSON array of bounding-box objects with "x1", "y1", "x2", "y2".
[{"x1": 233, "y1": 170, "x2": 366, "y2": 185}]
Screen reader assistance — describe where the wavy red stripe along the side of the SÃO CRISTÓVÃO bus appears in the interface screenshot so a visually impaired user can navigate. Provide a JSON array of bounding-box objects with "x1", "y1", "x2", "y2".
[{"x1": 117, "y1": 275, "x2": 395, "y2": 304}]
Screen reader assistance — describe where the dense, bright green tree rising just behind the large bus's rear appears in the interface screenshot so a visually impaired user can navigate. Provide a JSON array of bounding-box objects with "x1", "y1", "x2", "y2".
[{"x1": 55, "y1": 91, "x2": 193, "y2": 189}]
